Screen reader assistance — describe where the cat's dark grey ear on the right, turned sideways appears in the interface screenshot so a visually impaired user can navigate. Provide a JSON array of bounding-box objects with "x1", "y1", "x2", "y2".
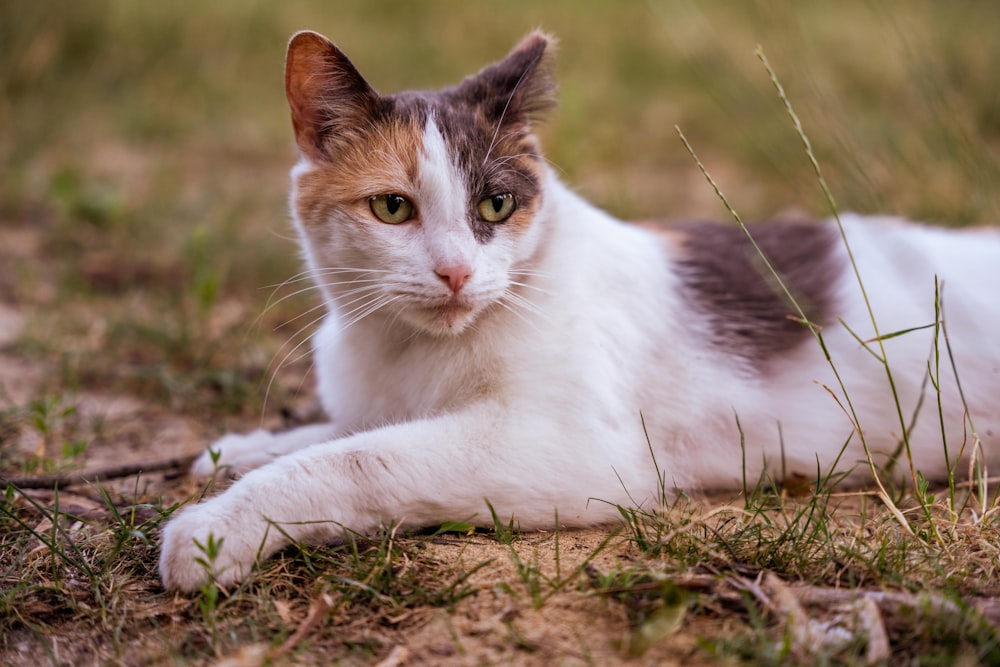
[{"x1": 457, "y1": 30, "x2": 556, "y2": 125}]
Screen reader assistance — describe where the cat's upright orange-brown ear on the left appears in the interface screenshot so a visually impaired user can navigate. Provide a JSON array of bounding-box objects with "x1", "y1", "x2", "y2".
[{"x1": 285, "y1": 30, "x2": 379, "y2": 159}]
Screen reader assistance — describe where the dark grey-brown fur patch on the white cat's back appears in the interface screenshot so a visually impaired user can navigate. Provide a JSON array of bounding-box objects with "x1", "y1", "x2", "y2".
[{"x1": 666, "y1": 222, "x2": 844, "y2": 364}]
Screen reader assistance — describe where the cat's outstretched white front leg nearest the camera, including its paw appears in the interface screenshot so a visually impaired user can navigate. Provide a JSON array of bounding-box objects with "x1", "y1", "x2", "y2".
[{"x1": 160, "y1": 409, "x2": 632, "y2": 591}]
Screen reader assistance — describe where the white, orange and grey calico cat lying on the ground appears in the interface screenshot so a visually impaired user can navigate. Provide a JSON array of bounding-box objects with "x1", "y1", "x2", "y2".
[{"x1": 160, "y1": 32, "x2": 1000, "y2": 591}]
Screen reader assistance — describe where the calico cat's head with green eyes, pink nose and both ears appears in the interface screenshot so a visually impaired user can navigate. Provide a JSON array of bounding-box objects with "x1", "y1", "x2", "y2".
[{"x1": 285, "y1": 32, "x2": 554, "y2": 335}]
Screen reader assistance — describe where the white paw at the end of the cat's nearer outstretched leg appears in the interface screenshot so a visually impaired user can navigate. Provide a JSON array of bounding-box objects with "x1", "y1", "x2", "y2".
[{"x1": 160, "y1": 498, "x2": 264, "y2": 592}]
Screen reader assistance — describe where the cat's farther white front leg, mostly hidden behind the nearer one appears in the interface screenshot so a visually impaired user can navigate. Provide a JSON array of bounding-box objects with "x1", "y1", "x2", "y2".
[{"x1": 191, "y1": 423, "x2": 338, "y2": 477}]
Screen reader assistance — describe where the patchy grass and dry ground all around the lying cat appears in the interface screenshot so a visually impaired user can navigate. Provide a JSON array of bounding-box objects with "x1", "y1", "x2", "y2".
[{"x1": 0, "y1": 0, "x2": 1000, "y2": 664}]
